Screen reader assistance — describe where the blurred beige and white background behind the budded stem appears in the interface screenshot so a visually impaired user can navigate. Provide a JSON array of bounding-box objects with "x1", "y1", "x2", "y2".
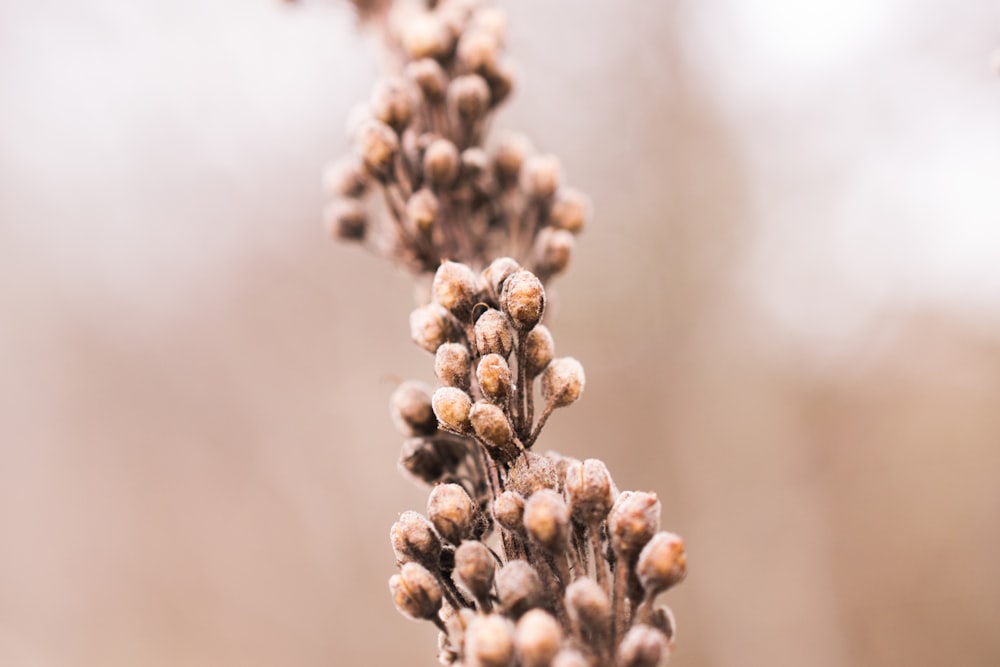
[{"x1": 0, "y1": 0, "x2": 1000, "y2": 667}]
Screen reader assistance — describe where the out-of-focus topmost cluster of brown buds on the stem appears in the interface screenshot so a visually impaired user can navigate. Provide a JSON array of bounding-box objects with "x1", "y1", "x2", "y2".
[{"x1": 324, "y1": 0, "x2": 590, "y2": 280}]
